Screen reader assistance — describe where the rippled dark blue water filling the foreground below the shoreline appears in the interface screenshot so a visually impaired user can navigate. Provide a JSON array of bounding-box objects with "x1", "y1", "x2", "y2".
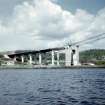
[{"x1": 0, "y1": 69, "x2": 105, "y2": 105}]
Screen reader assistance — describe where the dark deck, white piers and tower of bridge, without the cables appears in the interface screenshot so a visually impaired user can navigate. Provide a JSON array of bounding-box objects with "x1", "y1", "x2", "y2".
[{"x1": 8, "y1": 47, "x2": 79, "y2": 66}]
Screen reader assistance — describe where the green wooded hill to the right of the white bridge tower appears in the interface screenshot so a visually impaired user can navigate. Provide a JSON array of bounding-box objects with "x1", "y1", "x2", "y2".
[{"x1": 80, "y1": 49, "x2": 105, "y2": 64}]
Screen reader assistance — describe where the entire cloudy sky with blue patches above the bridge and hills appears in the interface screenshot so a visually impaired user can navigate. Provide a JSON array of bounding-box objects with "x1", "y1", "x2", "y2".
[{"x1": 0, "y1": 0, "x2": 105, "y2": 51}]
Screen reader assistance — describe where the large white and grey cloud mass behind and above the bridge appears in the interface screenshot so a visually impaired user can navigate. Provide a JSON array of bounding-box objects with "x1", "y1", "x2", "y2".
[{"x1": 0, "y1": 0, "x2": 105, "y2": 50}]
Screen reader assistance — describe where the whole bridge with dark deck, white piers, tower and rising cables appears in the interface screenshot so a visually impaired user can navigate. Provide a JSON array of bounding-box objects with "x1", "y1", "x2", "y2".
[{"x1": 2, "y1": 33, "x2": 105, "y2": 66}]
